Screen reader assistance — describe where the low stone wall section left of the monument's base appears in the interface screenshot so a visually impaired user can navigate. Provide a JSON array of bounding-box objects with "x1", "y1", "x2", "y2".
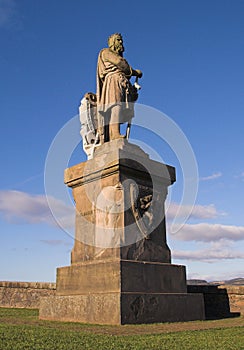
[{"x1": 0, "y1": 281, "x2": 56, "y2": 309}]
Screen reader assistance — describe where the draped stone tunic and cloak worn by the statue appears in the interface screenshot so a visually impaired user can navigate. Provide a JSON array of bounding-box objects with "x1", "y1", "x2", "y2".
[{"x1": 97, "y1": 48, "x2": 134, "y2": 123}]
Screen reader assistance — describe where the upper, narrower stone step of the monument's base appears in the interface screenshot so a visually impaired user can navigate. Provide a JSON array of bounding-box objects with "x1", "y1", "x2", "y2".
[{"x1": 57, "y1": 260, "x2": 186, "y2": 295}]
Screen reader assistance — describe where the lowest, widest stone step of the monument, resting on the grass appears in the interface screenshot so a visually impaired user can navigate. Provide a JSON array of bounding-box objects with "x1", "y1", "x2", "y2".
[{"x1": 39, "y1": 292, "x2": 204, "y2": 325}]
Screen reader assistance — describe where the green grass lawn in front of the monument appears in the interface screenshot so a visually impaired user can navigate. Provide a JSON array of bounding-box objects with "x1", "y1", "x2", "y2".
[{"x1": 0, "y1": 308, "x2": 244, "y2": 350}]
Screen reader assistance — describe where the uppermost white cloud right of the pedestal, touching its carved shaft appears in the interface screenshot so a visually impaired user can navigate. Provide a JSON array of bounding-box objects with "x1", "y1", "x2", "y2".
[{"x1": 166, "y1": 202, "x2": 225, "y2": 219}]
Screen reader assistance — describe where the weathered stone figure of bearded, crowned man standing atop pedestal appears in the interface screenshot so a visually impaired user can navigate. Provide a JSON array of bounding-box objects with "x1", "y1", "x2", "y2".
[{"x1": 97, "y1": 33, "x2": 142, "y2": 142}]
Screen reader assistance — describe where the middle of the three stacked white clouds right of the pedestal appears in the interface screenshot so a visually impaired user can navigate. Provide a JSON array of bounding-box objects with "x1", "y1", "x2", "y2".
[{"x1": 171, "y1": 223, "x2": 244, "y2": 242}]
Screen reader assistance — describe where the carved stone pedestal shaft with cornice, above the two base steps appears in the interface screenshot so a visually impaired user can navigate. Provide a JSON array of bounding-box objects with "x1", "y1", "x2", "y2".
[{"x1": 65, "y1": 139, "x2": 175, "y2": 264}]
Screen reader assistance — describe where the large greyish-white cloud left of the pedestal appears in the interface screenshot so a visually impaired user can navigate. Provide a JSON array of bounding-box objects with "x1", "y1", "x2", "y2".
[{"x1": 0, "y1": 191, "x2": 75, "y2": 228}]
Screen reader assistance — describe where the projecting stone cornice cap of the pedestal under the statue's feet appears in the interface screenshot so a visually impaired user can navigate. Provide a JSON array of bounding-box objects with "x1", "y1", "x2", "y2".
[{"x1": 64, "y1": 139, "x2": 176, "y2": 187}]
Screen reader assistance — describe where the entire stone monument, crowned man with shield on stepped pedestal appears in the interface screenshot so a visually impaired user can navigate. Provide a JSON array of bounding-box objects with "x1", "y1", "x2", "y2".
[{"x1": 40, "y1": 33, "x2": 204, "y2": 325}]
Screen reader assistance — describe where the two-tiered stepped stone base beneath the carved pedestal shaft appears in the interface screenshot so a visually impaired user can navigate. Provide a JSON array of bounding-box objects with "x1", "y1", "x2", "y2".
[{"x1": 39, "y1": 259, "x2": 204, "y2": 325}]
